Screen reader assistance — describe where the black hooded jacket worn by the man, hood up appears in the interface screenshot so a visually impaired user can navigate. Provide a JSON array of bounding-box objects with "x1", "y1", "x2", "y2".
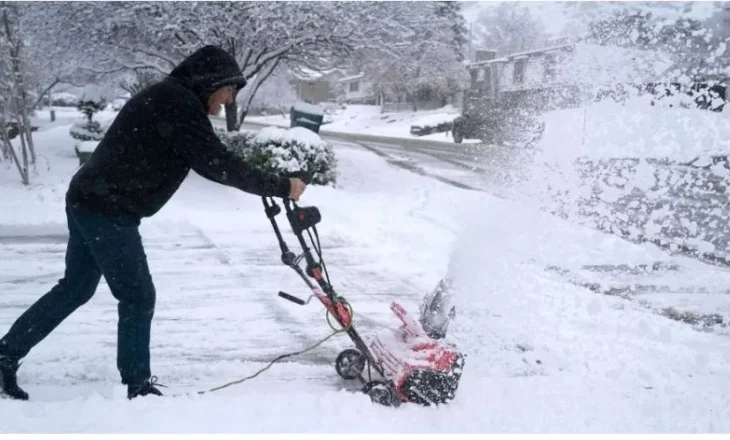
[{"x1": 66, "y1": 46, "x2": 290, "y2": 219}]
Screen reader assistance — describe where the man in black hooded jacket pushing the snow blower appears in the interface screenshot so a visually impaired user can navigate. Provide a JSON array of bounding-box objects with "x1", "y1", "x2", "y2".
[{"x1": 0, "y1": 46, "x2": 306, "y2": 400}]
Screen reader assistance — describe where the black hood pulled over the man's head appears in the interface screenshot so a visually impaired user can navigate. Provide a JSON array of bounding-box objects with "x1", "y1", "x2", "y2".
[{"x1": 169, "y1": 45, "x2": 246, "y2": 106}]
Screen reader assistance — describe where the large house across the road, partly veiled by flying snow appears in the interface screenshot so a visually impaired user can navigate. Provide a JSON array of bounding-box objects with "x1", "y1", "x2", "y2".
[{"x1": 453, "y1": 40, "x2": 672, "y2": 143}]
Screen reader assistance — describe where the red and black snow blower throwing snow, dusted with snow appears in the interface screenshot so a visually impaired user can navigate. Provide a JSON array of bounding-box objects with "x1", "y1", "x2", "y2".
[{"x1": 263, "y1": 197, "x2": 464, "y2": 406}]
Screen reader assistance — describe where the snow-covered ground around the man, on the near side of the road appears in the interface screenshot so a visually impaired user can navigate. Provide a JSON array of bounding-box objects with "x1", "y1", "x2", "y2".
[{"x1": 0, "y1": 114, "x2": 730, "y2": 433}]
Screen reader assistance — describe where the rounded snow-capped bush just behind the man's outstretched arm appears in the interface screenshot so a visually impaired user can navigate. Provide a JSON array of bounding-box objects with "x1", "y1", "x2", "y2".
[{"x1": 217, "y1": 127, "x2": 337, "y2": 185}]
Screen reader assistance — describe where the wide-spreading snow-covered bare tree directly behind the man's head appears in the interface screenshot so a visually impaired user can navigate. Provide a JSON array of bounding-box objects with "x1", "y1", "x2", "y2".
[{"x1": 48, "y1": 2, "x2": 359, "y2": 129}]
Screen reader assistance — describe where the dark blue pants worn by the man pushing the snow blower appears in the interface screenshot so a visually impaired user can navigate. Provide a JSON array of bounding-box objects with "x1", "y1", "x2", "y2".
[{"x1": 0, "y1": 206, "x2": 155, "y2": 384}]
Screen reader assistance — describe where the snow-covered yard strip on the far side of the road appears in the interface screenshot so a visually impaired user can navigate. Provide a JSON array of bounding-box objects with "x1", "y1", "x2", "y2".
[{"x1": 245, "y1": 105, "x2": 479, "y2": 144}]
